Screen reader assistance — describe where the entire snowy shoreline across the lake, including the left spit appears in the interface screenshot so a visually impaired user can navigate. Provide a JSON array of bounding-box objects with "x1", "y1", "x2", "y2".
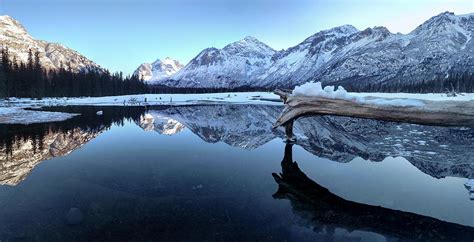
[{"x1": 0, "y1": 92, "x2": 474, "y2": 124}]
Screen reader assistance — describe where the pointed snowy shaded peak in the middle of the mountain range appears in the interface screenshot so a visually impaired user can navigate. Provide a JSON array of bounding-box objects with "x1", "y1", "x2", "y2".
[{"x1": 161, "y1": 36, "x2": 275, "y2": 88}]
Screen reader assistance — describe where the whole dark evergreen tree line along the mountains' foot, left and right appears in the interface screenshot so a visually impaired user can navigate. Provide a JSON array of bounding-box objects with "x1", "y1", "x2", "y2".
[{"x1": 0, "y1": 48, "x2": 474, "y2": 98}]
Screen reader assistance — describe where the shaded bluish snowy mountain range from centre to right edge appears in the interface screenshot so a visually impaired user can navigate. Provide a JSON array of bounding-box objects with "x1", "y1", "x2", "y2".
[{"x1": 161, "y1": 12, "x2": 474, "y2": 88}]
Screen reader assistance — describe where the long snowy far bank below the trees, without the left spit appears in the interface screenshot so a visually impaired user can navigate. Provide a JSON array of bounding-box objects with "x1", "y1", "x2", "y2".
[{"x1": 0, "y1": 90, "x2": 474, "y2": 107}]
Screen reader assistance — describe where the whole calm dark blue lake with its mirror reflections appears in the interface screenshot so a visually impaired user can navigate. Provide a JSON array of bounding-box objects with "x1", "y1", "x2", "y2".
[{"x1": 0, "y1": 104, "x2": 474, "y2": 241}]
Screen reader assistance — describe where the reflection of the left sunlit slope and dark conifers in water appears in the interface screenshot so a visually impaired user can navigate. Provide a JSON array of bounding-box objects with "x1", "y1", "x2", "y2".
[{"x1": 0, "y1": 107, "x2": 145, "y2": 185}]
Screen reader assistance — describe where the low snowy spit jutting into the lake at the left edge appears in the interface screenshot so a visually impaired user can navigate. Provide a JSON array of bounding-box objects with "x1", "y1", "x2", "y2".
[{"x1": 0, "y1": 107, "x2": 79, "y2": 124}]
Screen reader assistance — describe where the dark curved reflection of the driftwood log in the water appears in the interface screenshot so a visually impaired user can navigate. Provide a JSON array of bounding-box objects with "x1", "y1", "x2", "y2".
[{"x1": 272, "y1": 144, "x2": 474, "y2": 241}]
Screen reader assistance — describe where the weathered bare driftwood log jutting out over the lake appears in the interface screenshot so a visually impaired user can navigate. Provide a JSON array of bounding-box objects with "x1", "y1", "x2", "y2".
[{"x1": 273, "y1": 90, "x2": 474, "y2": 132}]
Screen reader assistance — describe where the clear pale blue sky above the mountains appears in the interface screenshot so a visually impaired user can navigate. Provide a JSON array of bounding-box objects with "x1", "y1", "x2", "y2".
[{"x1": 0, "y1": 0, "x2": 474, "y2": 74}]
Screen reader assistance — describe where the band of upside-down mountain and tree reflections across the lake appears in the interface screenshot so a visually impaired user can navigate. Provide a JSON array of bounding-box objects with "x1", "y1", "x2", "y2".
[{"x1": 0, "y1": 104, "x2": 474, "y2": 185}]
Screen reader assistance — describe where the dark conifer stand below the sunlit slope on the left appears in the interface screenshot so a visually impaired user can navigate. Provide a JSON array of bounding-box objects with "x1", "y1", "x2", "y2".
[{"x1": 0, "y1": 48, "x2": 149, "y2": 98}]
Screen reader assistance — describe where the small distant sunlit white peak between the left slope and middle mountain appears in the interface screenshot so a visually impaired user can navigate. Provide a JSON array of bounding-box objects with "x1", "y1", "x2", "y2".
[{"x1": 133, "y1": 57, "x2": 183, "y2": 84}]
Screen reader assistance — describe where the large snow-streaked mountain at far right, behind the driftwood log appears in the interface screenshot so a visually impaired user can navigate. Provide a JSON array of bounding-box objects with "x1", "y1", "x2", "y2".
[{"x1": 304, "y1": 12, "x2": 474, "y2": 88}]
